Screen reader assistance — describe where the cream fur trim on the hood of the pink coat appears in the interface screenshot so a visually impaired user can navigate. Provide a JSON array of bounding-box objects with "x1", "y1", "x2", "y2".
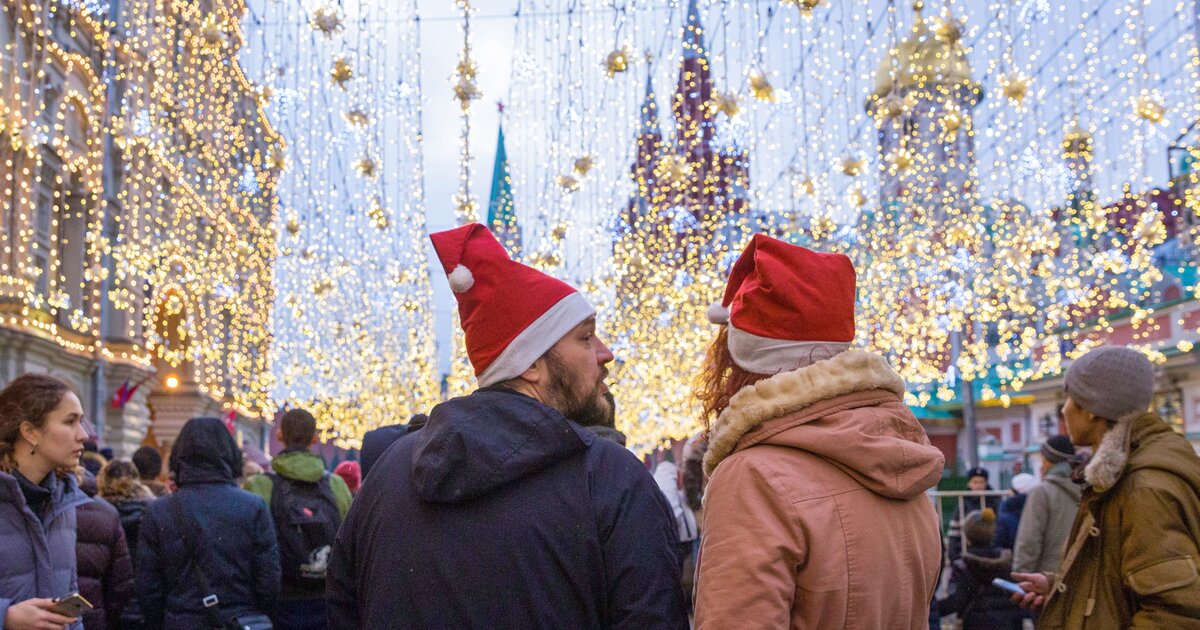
[{"x1": 704, "y1": 349, "x2": 905, "y2": 475}]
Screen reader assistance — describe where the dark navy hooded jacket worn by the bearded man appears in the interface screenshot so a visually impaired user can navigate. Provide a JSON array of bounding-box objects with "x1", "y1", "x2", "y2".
[{"x1": 326, "y1": 388, "x2": 688, "y2": 629}]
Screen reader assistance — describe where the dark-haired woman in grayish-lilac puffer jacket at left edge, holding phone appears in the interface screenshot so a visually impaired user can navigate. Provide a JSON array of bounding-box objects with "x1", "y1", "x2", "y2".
[{"x1": 0, "y1": 374, "x2": 91, "y2": 630}]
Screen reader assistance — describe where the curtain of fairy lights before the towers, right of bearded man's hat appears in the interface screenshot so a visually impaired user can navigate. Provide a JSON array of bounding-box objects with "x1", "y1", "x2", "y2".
[{"x1": 492, "y1": 0, "x2": 1200, "y2": 446}]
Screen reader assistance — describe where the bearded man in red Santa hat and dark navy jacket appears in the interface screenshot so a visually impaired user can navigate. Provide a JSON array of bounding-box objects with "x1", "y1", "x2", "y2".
[{"x1": 328, "y1": 224, "x2": 688, "y2": 629}]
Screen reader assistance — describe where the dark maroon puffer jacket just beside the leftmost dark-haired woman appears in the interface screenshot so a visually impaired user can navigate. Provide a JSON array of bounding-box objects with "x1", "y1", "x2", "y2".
[{"x1": 76, "y1": 498, "x2": 133, "y2": 630}]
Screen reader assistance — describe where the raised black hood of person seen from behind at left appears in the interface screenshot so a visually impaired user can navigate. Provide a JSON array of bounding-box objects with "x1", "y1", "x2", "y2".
[{"x1": 169, "y1": 418, "x2": 241, "y2": 486}]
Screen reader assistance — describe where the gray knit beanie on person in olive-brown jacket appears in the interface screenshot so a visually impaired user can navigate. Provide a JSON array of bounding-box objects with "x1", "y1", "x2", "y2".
[{"x1": 1066, "y1": 346, "x2": 1154, "y2": 421}]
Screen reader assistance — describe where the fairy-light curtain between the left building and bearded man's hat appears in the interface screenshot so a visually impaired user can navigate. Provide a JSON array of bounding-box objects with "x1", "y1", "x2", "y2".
[{"x1": 242, "y1": 0, "x2": 440, "y2": 446}]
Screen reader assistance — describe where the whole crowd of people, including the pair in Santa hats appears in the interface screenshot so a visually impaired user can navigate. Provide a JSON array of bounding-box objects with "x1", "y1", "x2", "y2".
[{"x1": 0, "y1": 224, "x2": 1200, "y2": 630}]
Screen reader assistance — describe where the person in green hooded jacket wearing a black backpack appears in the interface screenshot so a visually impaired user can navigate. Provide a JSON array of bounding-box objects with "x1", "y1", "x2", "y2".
[{"x1": 245, "y1": 409, "x2": 350, "y2": 630}]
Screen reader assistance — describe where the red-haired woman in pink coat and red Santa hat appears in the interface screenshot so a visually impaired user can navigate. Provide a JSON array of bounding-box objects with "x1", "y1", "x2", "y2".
[{"x1": 696, "y1": 234, "x2": 944, "y2": 629}]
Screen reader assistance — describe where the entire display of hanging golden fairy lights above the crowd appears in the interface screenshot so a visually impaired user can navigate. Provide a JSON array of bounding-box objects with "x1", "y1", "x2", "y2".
[{"x1": 0, "y1": 0, "x2": 1200, "y2": 449}]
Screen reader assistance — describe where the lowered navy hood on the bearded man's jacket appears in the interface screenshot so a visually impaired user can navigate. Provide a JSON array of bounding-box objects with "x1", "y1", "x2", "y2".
[{"x1": 406, "y1": 388, "x2": 599, "y2": 503}]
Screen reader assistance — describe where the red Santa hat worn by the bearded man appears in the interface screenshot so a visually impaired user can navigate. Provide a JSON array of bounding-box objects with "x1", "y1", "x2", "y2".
[{"x1": 430, "y1": 223, "x2": 595, "y2": 388}]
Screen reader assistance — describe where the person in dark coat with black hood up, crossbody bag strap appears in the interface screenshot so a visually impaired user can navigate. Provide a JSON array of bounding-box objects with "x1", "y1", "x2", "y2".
[{"x1": 136, "y1": 418, "x2": 280, "y2": 630}]
